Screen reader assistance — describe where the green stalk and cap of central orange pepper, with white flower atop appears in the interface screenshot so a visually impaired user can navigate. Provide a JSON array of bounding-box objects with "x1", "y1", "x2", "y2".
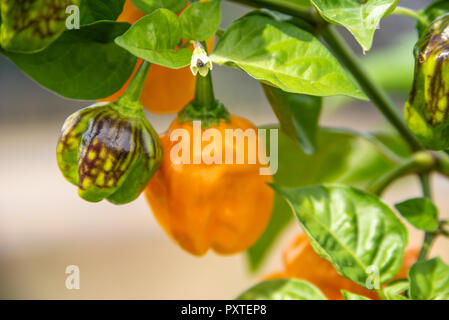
[{"x1": 178, "y1": 41, "x2": 230, "y2": 129}]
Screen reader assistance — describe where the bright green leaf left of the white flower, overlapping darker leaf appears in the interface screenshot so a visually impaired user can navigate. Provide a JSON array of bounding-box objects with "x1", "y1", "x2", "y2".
[{"x1": 115, "y1": 9, "x2": 192, "y2": 69}]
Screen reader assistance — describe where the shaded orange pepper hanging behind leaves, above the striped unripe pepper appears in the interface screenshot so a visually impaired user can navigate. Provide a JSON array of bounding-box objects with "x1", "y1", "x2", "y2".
[{"x1": 99, "y1": 0, "x2": 213, "y2": 114}]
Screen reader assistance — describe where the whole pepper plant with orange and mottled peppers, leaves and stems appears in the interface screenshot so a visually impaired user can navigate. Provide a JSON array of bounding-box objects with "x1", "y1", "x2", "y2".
[{"x1": 0, "y1": 0, "x2": 449, "y2": 300}]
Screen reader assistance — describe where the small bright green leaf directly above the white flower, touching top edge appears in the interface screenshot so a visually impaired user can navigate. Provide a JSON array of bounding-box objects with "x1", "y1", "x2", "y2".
[{"x1": 179, "y1": 0, "x2": 221, "y2": 41}]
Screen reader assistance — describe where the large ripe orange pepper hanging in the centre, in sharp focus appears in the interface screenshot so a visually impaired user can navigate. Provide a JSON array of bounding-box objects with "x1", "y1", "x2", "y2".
[{"x1": 145, "y1": 116, "x2": 274, "y2": 256}]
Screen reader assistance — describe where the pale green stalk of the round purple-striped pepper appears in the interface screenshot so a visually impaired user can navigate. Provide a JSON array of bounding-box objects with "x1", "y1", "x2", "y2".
[{"x1": 118, "y1": 60, "x2": 151, "y2": 111}]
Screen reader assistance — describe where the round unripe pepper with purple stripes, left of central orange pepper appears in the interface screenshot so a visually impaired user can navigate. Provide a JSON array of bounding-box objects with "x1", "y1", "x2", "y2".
[{"x1": 57, "y1": 102, "x2": 163, "y2": 204}]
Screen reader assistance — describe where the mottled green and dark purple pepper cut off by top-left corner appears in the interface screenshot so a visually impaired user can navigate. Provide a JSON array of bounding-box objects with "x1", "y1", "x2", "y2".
[{"x1": 0, "y1": 0, "x2": 80, "y2": 53}]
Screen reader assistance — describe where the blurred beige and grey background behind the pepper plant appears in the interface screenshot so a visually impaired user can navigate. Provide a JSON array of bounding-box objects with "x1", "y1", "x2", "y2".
[{"x1": 0, "y1": 0, "x2": 449, "y2": 299}]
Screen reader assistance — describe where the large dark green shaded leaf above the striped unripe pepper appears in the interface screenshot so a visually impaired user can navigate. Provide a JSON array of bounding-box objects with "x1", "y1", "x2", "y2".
[{"x1": 3, "y1": 21, "x2": 137, "y2": 100}]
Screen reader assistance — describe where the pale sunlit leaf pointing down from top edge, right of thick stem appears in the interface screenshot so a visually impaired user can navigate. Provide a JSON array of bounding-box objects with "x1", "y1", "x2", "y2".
[{"x1": 311, "y1": 0, "x2": 399, "y2": 51}]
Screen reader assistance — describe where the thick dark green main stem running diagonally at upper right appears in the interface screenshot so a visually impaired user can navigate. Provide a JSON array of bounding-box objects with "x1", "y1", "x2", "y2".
[{"x1": 322, "y1": 25, "x2": 422, "y2": 151}]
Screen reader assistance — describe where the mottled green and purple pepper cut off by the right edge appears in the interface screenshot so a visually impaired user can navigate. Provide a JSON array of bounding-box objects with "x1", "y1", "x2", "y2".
[{"x1": 405, "y1": 15, "x2": 449, "y2": 150}]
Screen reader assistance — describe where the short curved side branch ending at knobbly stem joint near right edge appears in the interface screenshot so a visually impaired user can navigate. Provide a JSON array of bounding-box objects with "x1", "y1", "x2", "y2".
[{"x1": 368, "y1": 151, "x2": 435, "y2": 196}]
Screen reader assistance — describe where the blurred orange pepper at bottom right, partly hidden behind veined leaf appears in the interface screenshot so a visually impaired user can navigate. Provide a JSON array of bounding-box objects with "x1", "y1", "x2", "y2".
[{"x1": 265, "y1": 233, "x2": 419, "y2": 300}]
